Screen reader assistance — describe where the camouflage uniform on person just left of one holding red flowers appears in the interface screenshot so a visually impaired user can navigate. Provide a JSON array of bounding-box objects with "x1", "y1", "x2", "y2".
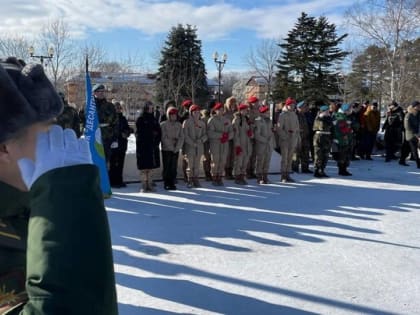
[{"x1": 313, "y1": 113, "x2": 333, "y2": 177}]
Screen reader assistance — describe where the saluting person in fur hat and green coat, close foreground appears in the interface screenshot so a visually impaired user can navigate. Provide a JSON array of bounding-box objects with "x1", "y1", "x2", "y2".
[{"x1": 0, "y1": 58, "x2": 118, "y2": 315}]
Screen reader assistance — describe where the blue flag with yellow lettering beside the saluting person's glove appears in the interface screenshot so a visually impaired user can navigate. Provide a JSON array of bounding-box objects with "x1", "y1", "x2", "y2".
[{"x1": 84, "y1": 70, "x2": 112, "y2": 198}]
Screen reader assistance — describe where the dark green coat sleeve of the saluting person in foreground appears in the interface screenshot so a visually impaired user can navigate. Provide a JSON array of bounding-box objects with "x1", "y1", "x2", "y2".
[{"x1": 0, "y1": 165, "x2": 118, "y2": 315}]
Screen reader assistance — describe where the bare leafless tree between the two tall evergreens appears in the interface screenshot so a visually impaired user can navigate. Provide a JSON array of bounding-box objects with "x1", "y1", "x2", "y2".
[{"x1": 246, "y1": 39, "x2": 281, "y2": 96}]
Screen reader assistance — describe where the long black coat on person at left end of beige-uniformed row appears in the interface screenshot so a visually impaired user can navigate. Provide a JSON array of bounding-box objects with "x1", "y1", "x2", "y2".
[{"x1": 136, "y1": 113, "x2": 162, "y2": 170}]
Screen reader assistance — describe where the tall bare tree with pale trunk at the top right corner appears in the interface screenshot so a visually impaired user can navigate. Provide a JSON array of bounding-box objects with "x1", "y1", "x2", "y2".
[{"x1": 346, "y1": 0, "x2": 420, "y2": 100}]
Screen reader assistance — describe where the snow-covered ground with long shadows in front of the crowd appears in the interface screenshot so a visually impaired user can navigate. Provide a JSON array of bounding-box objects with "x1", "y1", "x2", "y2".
[{"x1": 106, "y1": 144, "x2": 420, "y2": 315}]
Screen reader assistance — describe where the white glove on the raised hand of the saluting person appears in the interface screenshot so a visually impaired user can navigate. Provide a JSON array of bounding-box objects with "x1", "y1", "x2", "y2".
[{"x1": 18, "y1": 125, "x2": 92, "y2": 189}]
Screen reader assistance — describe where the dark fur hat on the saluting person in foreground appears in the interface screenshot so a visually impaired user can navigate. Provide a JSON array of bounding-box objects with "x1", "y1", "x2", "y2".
[{"x1": 0, "y1": 57, "x2": 63, "y2": 142}]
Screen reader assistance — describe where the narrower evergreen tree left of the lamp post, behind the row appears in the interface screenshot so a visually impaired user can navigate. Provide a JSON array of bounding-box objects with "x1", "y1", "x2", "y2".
[{"x1": 157, "y1": 24, "x2": 209, "y2": 104}]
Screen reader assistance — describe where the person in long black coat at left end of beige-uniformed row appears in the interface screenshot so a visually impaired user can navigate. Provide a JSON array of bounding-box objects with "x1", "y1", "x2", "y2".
[{"x1": 136, "y1": 101, "x2": 162, "y2": 192}]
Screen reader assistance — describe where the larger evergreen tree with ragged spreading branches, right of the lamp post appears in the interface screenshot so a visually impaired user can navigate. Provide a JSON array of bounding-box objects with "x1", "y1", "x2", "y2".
[{"x1": 276, "y1": 12, "x2": 348, "y2": 102}]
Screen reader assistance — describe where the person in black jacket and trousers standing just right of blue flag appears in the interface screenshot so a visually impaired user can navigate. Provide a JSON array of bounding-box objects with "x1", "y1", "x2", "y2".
[{"x1": 109, "y1": 102, "x2": 133, "y2": 188}]
